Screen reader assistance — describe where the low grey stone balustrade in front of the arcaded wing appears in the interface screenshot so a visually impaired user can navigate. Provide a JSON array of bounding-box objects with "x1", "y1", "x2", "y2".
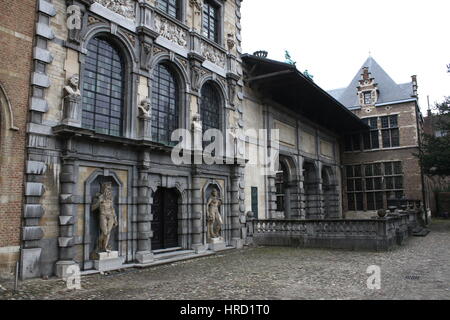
[{"x1": 246, "y1": 212, "x2": 414, "y2": 251}]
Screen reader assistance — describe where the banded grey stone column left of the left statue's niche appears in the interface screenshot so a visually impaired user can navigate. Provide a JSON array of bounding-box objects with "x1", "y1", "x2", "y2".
[{"x1": 56, "y1": 157, "x2": 77, "y2": 278}]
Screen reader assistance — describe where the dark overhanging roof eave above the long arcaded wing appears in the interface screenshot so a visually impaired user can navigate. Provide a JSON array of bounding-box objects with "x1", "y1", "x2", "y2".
[{"x1": 242, "y1": 54, "x2": 369, "y2": 134}]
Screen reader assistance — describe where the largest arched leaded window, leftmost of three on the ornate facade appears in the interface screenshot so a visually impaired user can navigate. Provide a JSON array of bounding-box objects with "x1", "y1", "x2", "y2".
[{"x1": 82, "y1": 37, "x2": 125, "y2": 136}]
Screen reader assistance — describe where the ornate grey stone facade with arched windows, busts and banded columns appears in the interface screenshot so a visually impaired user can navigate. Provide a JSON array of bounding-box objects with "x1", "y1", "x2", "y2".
[{"x1": 21, "y1": 0, "x2": 250, "y2": 278}]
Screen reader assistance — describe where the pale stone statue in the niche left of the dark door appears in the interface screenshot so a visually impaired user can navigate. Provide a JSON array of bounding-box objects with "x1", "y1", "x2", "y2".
[{"x1": 92, "y1": 182, "x2": 118, "y2": 252}]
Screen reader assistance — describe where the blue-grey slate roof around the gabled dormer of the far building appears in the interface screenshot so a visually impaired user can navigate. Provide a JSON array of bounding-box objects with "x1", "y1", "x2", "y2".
[{"x1": 328, "y1": 57, "x2": 414, "y2": 109}]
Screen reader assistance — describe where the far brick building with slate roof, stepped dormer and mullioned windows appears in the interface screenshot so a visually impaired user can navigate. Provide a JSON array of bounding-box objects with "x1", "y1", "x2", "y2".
[{"x1": 329, "y1": 57, "x2": 429, "y2": 217}]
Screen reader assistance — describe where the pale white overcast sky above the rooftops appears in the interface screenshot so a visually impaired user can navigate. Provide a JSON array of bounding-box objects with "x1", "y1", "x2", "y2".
[{"x1": 241, "y1": 0, "x2": 450, "y2": 112}]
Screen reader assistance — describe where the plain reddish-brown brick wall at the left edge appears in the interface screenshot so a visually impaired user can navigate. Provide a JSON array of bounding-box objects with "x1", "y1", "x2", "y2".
[{"x1": 0, "y1": 0, "x2": 36, "y2": 272}]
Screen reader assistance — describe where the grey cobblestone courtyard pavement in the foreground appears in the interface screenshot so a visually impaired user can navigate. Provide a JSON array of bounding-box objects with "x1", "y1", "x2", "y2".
[{"x1": 0, "y1": 220, "x2": 450, "y2": 300}]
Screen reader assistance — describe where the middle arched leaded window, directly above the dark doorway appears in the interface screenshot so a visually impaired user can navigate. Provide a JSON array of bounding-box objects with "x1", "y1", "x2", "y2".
[{"x1": 152, "y1": 64, "x2": 180, "y2": 145}]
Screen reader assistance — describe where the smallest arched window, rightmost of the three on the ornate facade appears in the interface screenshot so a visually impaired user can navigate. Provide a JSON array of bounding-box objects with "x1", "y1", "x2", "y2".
[{"x1": 200, "y1": 82, "x2": 221, "y2": 132}]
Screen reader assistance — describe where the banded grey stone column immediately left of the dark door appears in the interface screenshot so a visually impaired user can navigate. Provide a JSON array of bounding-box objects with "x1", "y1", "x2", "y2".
[{"x1": 136, "y1": 165, "x2": 154, "y2": 264}]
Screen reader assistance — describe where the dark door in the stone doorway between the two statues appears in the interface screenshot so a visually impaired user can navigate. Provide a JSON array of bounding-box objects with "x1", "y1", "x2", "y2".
[{"x1": 152, "y1": 188, "x2": 178, "y2": 250}]
